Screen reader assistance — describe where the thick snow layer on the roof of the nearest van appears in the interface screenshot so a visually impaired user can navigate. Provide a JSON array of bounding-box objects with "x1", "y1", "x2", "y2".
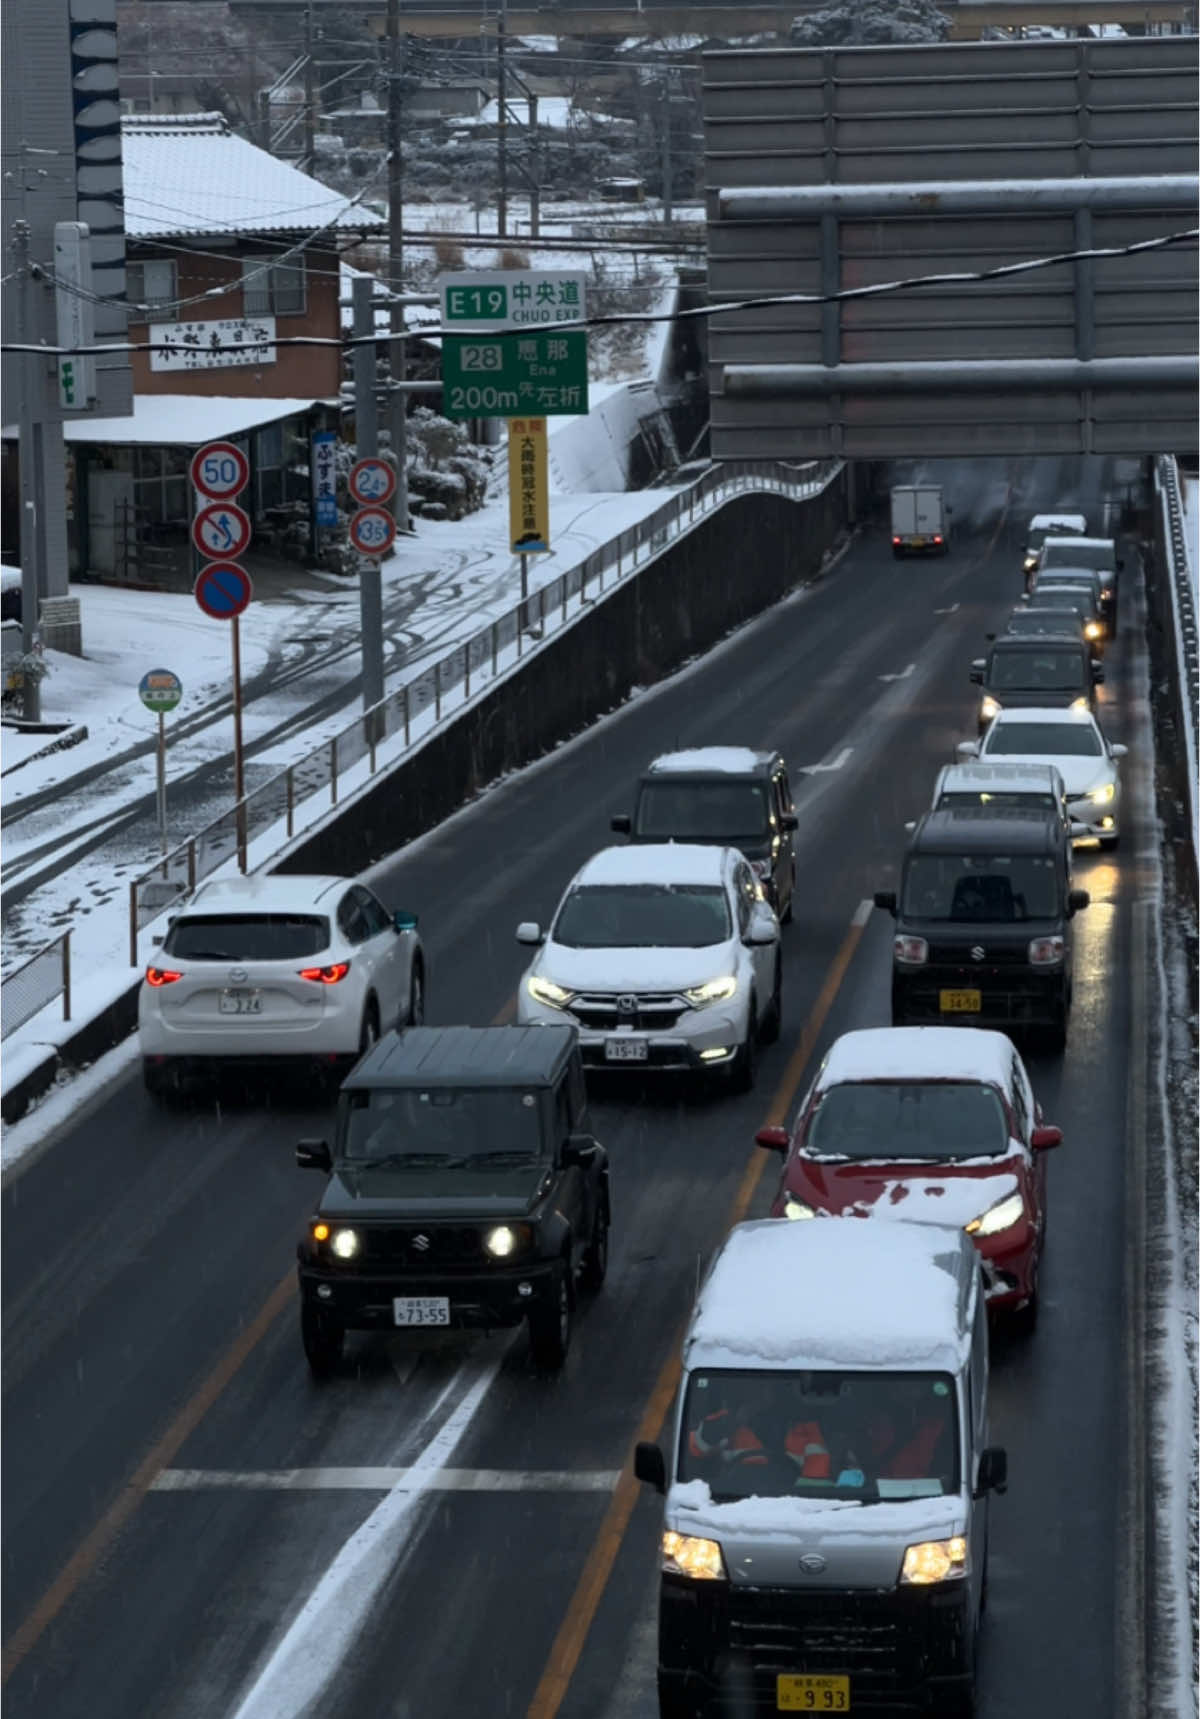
[{"x1": 684, "y1": 1217, "x2": 978, "y2": 1372}]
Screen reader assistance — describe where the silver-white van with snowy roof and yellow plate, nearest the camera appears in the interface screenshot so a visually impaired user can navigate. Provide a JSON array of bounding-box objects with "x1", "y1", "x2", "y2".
[{"x1": 634, "y1": 1217, "x2": 1007, "y2": 1719}]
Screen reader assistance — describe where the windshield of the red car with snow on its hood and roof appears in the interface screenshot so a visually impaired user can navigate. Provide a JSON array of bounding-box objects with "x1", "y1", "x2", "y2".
[{"x1": 805, "y1": 1080, "x2": 1009, "y2": 1162}]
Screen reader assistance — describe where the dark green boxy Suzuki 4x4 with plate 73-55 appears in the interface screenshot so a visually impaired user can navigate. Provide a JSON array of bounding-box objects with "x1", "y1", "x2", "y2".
[{"x1": 296, "y1": 1025, "x2": 610, "y2": 1377}]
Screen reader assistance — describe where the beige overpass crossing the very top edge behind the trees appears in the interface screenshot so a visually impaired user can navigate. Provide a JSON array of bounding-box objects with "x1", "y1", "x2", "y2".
[{"x1": 230, "y1": 0, "x2": 1197, "y2": 41}]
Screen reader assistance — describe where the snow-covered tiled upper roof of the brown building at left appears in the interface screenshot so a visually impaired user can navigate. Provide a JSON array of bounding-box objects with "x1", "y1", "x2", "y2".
[{"x1": 120, "y1": 113, "x2": 385, "y2": 239}]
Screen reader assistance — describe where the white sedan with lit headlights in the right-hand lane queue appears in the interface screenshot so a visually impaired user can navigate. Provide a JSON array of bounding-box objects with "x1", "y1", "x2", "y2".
[{"x1": 958, "y1": 708, "x2": 1128, "y2": 847}]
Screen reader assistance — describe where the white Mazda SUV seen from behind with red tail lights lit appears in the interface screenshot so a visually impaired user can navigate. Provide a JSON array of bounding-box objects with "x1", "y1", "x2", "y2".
[{"x1": 138, "y1": 875, "x2": 425, "y2": 1095}]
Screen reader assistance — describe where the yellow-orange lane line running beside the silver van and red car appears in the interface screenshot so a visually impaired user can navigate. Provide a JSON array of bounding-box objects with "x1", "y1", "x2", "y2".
[{"x1": 526, "y1": 915, "x2": 866, "y2": 1719}]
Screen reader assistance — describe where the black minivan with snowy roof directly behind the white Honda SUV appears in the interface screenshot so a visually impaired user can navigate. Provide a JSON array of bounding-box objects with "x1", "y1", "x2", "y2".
[{"x1": 610, "y1": 746, "x2": 798, "y2": 925}]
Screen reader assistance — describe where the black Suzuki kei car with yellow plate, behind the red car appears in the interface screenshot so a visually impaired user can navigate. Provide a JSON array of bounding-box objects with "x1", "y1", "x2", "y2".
[{"x1": 875, "y1": 808, "x2": 1088, "y2": 1049}]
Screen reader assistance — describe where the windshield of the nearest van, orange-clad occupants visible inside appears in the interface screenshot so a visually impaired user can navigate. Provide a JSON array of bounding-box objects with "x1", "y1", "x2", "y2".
[{"x1": 677, "y1": 1368, "x2": 959, "y2": 1504}]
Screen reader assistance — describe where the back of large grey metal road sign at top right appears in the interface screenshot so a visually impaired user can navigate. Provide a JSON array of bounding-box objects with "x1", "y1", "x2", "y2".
[{"x1": 703, "y1": 36, "x2": 1198, "y2": 459}]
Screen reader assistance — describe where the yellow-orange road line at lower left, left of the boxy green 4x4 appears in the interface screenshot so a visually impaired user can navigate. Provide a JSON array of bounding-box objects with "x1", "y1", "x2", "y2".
[{"x1": 0, "y1": 1272, "x2": 296, "y2": 1683}]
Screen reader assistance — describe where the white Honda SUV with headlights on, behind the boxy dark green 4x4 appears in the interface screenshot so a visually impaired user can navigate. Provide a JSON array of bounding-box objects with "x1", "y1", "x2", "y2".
[{"x1": 517, "y1": 842, "x2": 782, "y2": 1092}]
